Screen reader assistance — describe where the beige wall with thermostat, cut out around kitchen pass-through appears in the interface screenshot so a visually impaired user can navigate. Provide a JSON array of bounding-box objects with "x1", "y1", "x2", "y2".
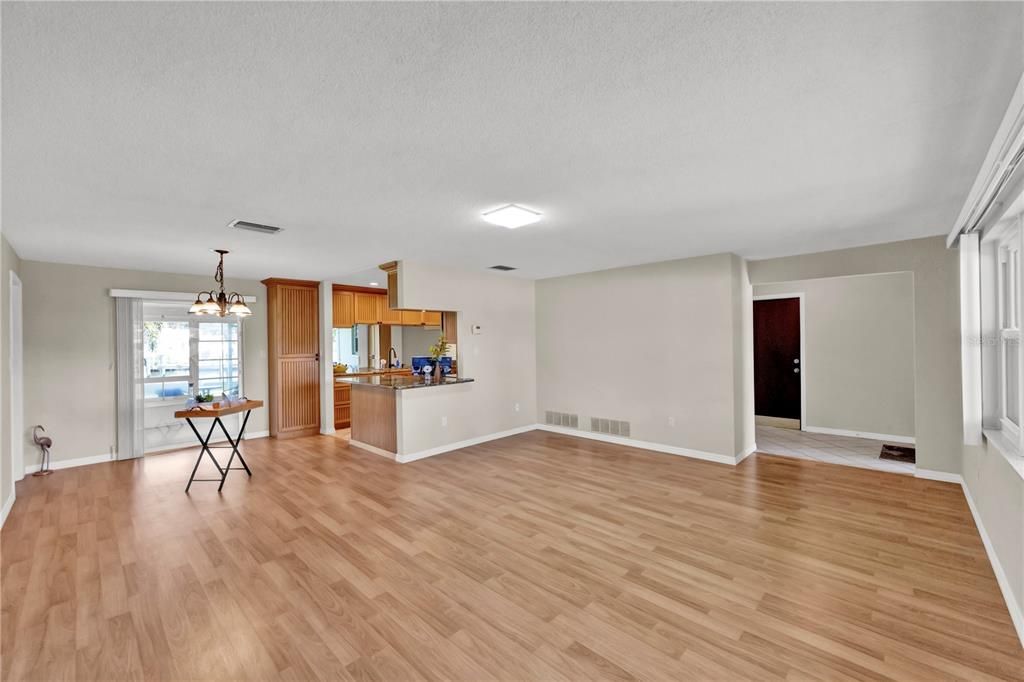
[{"x1": 398, "y1": 261, "x2": 537, "y2": 455}]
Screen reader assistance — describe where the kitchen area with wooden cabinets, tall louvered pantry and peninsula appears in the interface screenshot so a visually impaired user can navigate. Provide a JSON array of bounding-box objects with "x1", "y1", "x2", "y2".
[{"x1": 262, "y1": 262, "x2": 481, "y2": 462}]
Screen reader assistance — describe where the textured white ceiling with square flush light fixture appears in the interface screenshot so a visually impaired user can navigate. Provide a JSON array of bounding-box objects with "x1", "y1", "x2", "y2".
[{"x1": 2, "y1": 2, "x2": 1024, "y2": 280}]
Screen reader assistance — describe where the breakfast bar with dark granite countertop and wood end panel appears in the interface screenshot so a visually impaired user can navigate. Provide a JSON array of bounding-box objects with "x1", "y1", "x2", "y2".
[{"x1": 335, "y1": 374, "x2": 473, "y2": 460}]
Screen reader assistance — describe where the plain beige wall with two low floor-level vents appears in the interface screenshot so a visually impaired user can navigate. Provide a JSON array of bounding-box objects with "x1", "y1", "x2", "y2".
[{"x1": 537, "y1": 249, "x2": 753, "y2": 458}]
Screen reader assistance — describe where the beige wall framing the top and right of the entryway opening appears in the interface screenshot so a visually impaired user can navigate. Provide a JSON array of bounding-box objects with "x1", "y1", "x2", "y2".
[{"x1": 748, "y1": 237, "x2": 964, "y2": 474}]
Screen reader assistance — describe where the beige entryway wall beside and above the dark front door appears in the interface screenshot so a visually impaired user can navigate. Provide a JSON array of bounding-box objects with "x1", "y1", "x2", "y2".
[{"x1": 754, "y1": 272, "x2": 914, "y2": 437}]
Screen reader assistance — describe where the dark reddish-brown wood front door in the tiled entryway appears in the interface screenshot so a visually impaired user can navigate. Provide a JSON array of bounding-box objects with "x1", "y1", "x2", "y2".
[{"x1": 754, "y1": 298, "x2": 804, "y2": 419}]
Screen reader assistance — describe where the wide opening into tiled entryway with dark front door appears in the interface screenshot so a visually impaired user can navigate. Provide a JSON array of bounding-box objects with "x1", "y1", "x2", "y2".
[{"x1": 752, "y1": 272, "x2": 916, "y2": 474}]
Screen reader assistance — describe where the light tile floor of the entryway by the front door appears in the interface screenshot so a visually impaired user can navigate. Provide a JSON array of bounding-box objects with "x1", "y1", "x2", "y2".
[{"x1": 757, "y1": 425, "x2": 914, "y2": 475}]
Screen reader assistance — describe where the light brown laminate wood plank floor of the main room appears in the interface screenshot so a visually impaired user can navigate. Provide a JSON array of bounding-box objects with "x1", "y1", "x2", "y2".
[{"x1": 0, "y1": 431, "x2": 1024, "y2": 681}]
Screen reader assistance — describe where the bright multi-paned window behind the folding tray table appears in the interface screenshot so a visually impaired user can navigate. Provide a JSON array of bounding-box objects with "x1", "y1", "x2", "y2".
[{"x1": 142, "y1": 302, "x2": 242, "y2": 402}]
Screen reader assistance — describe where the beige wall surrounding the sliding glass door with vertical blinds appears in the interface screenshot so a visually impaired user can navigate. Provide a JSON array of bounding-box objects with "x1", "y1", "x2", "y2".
[{"x1": 22, "y1": 260, "x2": 267, "y2": 465}]
